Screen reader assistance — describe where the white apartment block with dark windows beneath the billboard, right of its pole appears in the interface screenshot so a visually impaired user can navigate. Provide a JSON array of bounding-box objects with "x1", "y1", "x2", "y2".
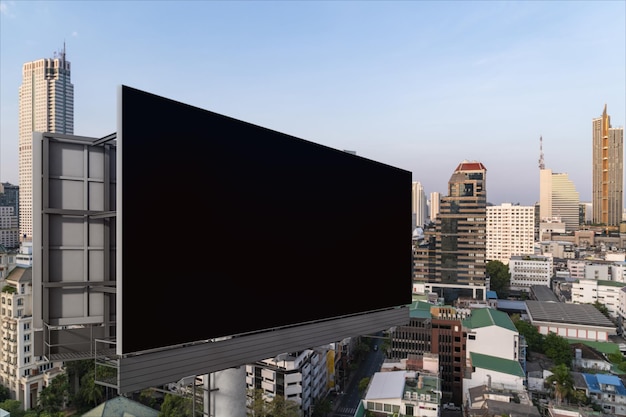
[{"x1": 246, "y1": 347, "x2": 332, "y2": 417}]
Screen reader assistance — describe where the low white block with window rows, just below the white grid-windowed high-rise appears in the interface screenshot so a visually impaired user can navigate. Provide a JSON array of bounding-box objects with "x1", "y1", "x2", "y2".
[{"x1": 509, "y1": 255, "x2": 554, "y2": 292}]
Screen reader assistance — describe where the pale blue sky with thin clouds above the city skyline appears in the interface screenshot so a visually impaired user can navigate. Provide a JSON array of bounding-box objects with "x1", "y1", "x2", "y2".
[{"x1": 0, "y1": 0, "x2": 626, "y2": 205}]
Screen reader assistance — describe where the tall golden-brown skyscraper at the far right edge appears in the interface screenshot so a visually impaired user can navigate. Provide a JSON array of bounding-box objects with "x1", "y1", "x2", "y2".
[{"x1": 591, "y1": 104, "x2": 624, "y2": 229}]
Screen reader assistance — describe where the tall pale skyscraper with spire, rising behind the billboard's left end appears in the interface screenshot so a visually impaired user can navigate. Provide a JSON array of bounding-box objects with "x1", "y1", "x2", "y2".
[{"x1": 18, "y1": 46, "x2": 74, "y2": 239}]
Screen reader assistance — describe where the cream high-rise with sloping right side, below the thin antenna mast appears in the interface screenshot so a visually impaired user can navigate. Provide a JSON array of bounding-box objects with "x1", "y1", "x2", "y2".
[{"x1": 539, "y1": 168, "x2": 580, "y2": 232}]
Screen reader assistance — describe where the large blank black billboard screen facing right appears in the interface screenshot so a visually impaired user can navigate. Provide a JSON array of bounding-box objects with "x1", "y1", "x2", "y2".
[{"x1": 117, "y1": 86, "x2": 412, "y2": 353}]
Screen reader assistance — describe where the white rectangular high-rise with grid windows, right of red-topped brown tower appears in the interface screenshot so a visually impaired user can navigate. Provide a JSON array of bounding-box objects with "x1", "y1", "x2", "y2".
[{"x1": 486, "y1": 203, "x2": 535, "y2": 265}]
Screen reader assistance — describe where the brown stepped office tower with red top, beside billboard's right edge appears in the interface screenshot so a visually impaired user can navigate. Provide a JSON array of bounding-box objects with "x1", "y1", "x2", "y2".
[{"x1": 413, "y1": 161, "x2": 488, "y2": 302}]
